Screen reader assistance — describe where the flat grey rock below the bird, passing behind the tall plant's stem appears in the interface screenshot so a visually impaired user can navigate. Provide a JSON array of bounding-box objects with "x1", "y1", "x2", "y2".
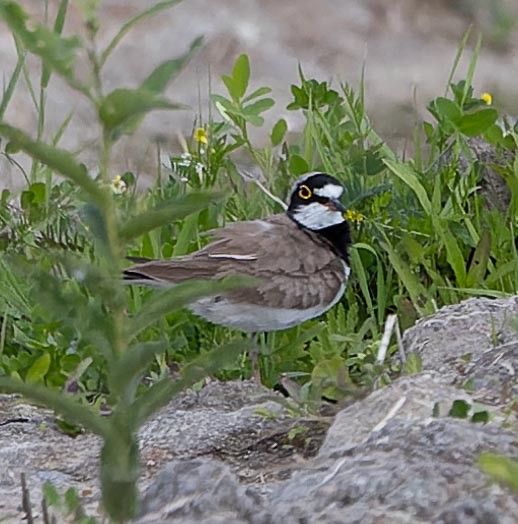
[{"x1": 0, "y1": 381, "x2": 330, "y2": 523}]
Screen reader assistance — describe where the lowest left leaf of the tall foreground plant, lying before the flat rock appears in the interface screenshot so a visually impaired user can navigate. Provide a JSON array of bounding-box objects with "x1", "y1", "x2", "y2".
[{"x1": 0, "y1": 377, "x2": 111, "y2": 437}]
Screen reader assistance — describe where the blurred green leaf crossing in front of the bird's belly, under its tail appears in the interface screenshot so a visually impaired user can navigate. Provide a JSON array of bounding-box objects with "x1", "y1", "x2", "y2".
[{"x1": 127, "y1": 276, "x2": 257, "y2": 339}]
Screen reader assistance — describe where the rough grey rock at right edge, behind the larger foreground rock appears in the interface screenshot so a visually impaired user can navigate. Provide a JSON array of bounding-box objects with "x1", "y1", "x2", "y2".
[{"x1": 403, "y1": 296, "x2": 518, "y2": 405}]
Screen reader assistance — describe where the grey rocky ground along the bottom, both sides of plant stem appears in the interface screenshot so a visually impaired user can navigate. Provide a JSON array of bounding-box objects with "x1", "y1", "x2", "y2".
[{"x1": 0, "y1": 296, "x2": 518, "y2": 524}]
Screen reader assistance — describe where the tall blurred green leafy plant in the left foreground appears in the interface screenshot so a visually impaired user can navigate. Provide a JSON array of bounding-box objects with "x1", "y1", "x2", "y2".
[{"x1": 0, "y1": 1, "x2": 252, "y2": 522}]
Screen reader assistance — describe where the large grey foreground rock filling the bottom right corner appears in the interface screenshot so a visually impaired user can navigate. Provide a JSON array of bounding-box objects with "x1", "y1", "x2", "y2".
[{"x1": 268, "y1": 419, "x2": 518, "y2": 524}]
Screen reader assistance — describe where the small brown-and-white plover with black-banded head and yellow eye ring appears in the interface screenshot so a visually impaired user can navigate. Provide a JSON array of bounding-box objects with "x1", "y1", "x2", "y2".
[{"x1": 124, "y1": 172, "x2": 351, "y2": 381}]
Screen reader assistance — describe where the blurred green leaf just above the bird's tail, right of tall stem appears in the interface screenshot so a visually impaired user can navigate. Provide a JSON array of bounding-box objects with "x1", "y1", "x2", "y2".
[{"x1": 120, "y1": 193, "x2": 222, "y2": 242}]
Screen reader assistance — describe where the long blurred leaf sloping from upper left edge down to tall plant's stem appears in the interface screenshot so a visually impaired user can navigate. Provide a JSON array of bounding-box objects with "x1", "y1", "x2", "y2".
[{"x1": 0, "y1": 122, "x2": 104, "y2": 201}]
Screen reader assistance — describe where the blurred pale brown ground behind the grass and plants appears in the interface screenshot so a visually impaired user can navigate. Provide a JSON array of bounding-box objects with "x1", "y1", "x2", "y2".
[{"x1": 0, "y1": 0, "x2": 518, "y2": 187}]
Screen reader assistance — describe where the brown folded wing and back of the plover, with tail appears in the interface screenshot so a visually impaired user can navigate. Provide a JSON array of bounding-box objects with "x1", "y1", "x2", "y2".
[{"x1": 125, "y1": 215, "x2": 344, "y2": 309}]
